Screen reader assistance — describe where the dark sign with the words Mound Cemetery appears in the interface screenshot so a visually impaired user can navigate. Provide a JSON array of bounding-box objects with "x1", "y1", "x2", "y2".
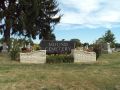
[{"x1": 40, "y1": 40, "x2": 75, "y2": 54}]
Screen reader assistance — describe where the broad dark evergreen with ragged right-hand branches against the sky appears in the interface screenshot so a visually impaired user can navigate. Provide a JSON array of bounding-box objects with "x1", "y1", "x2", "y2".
[{"x1": 16, "y1": 0, "x2": 61, "y2": 40}]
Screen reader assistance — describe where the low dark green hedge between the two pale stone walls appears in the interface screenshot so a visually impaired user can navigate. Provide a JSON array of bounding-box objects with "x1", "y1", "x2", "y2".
[{"x1": 46, "y1": 55, "x2": 74, "y2": 63}]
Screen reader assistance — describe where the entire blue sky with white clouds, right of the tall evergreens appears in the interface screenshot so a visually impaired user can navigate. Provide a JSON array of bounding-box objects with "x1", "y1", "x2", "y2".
[{"x1": 51, "y1": 0, "x2": 120, "y2": 43}]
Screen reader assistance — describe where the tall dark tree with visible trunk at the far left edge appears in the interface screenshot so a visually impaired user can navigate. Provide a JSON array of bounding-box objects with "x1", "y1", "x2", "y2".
[{"x1": 0, "y1": 0, "x2": 20, "y2": 42}]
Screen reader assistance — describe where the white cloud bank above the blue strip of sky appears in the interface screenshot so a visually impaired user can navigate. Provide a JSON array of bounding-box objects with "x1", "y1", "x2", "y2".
[{"x1": 59, "y1": 0, "x2": 120, "y2": 28}]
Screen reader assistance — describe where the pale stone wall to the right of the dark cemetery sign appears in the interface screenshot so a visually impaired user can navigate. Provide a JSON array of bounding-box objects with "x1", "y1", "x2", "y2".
[{"x1": 72, "y1": 50, "x2": 96, "y2": 63}]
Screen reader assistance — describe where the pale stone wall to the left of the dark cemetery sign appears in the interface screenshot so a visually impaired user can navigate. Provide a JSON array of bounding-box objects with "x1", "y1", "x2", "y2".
[{"x1": 20, "y1": 50, "x2": 46, "y2": 64}]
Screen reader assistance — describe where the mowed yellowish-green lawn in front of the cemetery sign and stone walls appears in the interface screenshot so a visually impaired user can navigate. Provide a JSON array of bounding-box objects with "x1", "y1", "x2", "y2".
[{"x1": 0, "y1": 53, "x2": 120, "y2": 90}]
